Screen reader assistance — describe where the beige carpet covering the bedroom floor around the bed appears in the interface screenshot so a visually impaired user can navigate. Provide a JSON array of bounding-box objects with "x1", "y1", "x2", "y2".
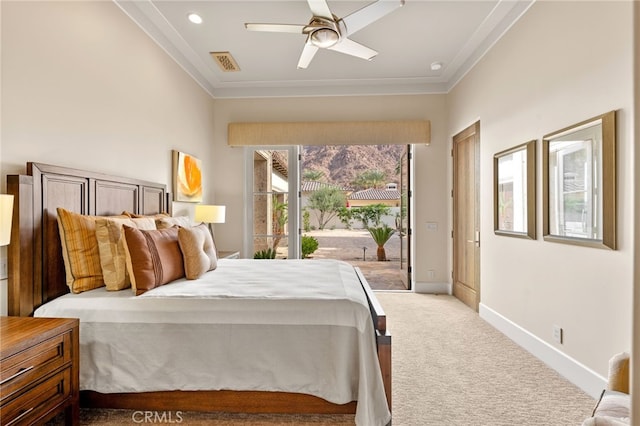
[{"x1": 48, "y1": 293, "x2": 595, "y2": 426}]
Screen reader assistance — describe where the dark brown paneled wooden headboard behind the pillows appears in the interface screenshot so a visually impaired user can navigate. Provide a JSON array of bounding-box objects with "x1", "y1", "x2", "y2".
[{"x1": 7, "y1": 163, "x2": 169, "y2": 316}]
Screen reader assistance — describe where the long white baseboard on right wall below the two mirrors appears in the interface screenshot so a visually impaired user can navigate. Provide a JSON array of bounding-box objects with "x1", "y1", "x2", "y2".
[{"x1": 479, "y1": 303, "x2": 607, "y2": 399}]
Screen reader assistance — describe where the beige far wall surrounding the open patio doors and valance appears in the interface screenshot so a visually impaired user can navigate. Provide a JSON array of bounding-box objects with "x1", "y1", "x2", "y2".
[{"x1": 214, "y1": 95, "x2": 450, "y2": 282}]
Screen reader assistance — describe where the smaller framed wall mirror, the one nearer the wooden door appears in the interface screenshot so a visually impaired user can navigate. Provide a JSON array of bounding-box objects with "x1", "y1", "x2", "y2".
[{"x1": 493, "y1": 140, "x2": 536, "y2": 239}]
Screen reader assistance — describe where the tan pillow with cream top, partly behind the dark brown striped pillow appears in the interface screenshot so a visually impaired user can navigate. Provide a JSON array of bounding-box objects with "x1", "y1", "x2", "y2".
[{"x1": 96, "y1": 218, "x2": 156, "y2": 291}]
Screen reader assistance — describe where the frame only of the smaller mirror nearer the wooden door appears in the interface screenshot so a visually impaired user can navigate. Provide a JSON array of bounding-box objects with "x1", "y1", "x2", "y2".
[{"x1": 493, "y1": 140, "x2": 537, "y2": 240}]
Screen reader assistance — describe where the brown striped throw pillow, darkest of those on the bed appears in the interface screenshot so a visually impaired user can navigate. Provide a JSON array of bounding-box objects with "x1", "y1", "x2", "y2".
[{"x1": 122, "y1": 225, "x2": 184, "y2": 296}]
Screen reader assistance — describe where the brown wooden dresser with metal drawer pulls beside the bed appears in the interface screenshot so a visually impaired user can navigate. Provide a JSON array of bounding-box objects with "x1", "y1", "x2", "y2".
[{"x1": 0, "y1": 317, "x2": 80, "y2": 426}]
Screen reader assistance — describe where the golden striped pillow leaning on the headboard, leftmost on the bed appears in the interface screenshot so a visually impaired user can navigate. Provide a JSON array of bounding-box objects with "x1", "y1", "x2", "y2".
[{"x1": 56, "y1": 207, "x2": 127, "y2": 293}]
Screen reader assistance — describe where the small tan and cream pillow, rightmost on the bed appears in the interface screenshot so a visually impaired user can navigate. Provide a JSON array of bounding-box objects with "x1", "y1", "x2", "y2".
[{"x1": 178, "y1": 224, "x2": 218, "y2": 280}]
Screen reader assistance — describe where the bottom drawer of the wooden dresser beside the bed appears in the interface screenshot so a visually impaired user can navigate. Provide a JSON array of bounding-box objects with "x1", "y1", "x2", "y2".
[{"x1": 0, "y1": 368, "x2": 71, "y2": 426}]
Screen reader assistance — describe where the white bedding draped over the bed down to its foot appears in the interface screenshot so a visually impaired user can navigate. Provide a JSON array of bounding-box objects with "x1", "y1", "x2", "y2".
[{"x1": 34, "y1": 259, "x2": 390, "y2": 426}]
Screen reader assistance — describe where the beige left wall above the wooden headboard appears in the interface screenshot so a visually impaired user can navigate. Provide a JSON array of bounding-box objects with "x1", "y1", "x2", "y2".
[{"x1": 0, "y1": 1, "x2": 214, "y2": 313}]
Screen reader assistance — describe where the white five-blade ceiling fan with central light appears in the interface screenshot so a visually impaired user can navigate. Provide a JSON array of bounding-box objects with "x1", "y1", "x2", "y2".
[{"x1": 244, "y1": 0, "x2": 405, "y2": 68}]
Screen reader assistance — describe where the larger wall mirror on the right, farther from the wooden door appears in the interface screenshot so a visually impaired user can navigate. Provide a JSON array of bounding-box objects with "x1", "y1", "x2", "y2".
[{"x1": 542, "y1": 111, "x2": 616, "y2": 249}]
